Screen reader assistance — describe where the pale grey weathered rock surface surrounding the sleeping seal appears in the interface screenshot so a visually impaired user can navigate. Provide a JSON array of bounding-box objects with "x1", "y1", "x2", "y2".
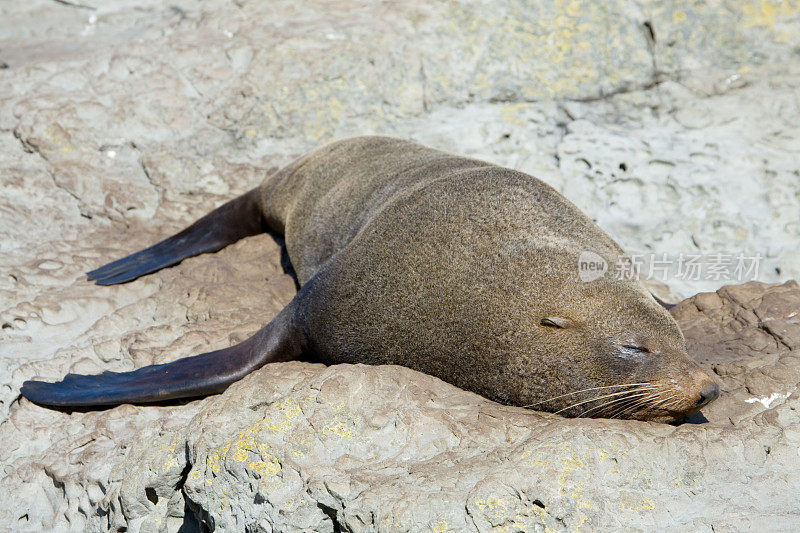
[{"x1": 0, "y1": 0, "x2": 800, "y2": 531}]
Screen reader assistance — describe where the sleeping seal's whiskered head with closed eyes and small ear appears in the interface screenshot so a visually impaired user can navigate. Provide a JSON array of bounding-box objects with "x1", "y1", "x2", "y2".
[{"x1": 532, "y1": 278, "x2": 719, "y2": 422}]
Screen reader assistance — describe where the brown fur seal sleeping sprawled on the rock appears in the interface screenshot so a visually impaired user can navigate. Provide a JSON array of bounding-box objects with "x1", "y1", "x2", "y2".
[{"x1": 22, "y1": 137, "x2": 719, "y2": 422}]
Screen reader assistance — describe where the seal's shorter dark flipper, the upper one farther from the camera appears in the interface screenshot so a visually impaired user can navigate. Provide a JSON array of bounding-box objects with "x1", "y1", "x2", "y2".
[{"x1": 88, "y1": 189, "x2": 266, "y2": 285}]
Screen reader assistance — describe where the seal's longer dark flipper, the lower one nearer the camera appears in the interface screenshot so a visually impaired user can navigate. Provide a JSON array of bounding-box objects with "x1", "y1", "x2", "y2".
[{"x1": 21, "y1": 304, "x2": 304, "y2": 407}]
